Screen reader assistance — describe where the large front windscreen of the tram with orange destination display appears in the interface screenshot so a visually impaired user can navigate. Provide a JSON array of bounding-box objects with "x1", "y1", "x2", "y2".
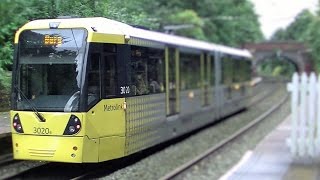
[{"x1": 14, "y1": 29, "x2": 87, "y2": 112}]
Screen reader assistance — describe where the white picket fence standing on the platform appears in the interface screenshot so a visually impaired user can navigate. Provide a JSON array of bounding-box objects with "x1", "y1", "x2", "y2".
[{"x1": 287, "y1": 73, "x2": 320, "y2": 158}]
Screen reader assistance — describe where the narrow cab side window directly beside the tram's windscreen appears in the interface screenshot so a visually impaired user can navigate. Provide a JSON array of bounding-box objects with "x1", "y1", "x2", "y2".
[{"x1": 88, "y1": 53, "x2": 100, "y2": 106}]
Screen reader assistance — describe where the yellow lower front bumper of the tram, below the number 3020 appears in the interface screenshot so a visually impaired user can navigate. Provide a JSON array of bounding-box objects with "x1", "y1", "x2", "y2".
[{"x1": 12, "y1": 134, "x2": 99, "y2": 163}]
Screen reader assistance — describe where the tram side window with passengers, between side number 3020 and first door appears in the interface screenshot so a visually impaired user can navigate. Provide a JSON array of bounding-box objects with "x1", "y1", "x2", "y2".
[{"x1": 131, "y1": 46, "x2": 165, "y2": 96}]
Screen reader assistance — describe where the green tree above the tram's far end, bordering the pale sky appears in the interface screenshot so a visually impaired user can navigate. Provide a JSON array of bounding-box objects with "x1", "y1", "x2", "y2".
[{"x1": 188, "y1": 0, "x2": 263, "y2": 46}]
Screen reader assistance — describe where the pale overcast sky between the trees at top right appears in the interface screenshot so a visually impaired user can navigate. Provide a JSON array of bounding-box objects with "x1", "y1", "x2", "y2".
[{"x1": 250, "y1": 0, "x2": 318, "y2": 38}]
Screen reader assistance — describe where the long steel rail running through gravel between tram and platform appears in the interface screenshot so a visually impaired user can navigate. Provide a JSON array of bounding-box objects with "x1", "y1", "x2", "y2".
[{"x1": 160, "y1": 90, "x2": 289, "y2": 180}]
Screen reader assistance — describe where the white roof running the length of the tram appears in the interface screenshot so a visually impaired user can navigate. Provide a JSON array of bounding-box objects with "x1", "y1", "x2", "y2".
[{"x1": 20, "y1": 17, "x2": 252, "y2": 57}]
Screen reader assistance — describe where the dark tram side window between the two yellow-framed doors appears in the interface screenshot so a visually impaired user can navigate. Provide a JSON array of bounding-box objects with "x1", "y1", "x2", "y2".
[{"x1": 180, "y1": 53, "x2": 201, "y2": 91}]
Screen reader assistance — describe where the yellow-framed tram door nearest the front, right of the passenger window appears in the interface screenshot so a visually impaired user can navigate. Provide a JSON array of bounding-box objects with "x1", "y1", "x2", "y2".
[{"x1": 166, "y1": 48, "x2": 179, "y2": 116}]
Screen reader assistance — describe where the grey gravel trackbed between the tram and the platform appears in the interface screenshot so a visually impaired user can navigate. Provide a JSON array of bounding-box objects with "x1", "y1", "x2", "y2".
[{"x1": 102, "y1": 85, "x2": 289, "y2": 180}]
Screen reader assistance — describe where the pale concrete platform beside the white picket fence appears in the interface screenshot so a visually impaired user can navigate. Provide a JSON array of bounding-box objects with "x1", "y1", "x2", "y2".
[{"x1": 220, "y1": 117, "x2": 320, "y2": 180}]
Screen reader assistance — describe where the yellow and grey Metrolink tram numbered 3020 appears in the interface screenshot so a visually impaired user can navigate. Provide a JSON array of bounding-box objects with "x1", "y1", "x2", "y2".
[{"x1": 10, "y1": 18, "x2": 251, "y2": 163}]
